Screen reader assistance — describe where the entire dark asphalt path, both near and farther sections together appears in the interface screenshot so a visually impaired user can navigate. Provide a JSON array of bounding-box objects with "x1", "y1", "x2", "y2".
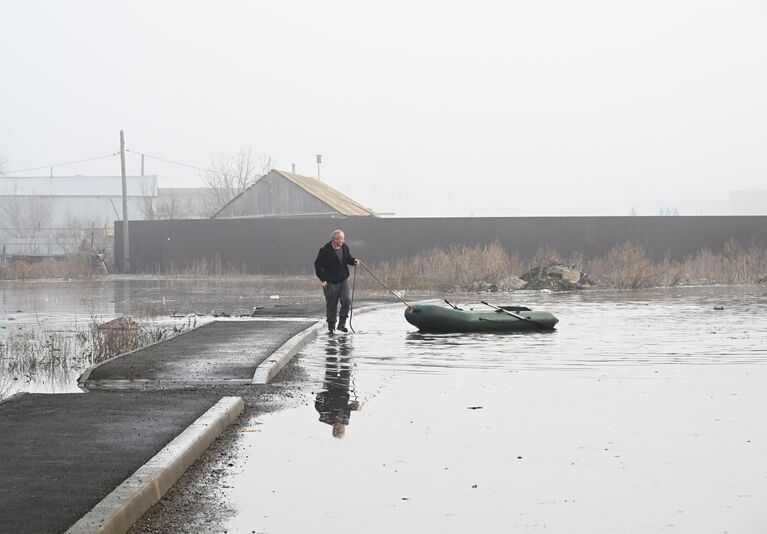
[{"x1": 0, "y1": 302, "x2": 384, "y2": 534}]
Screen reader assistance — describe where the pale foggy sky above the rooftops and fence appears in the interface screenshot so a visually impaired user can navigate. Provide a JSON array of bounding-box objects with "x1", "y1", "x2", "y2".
[{"x1": 0, "y1": 0, "x2": 767, "y2": 216}]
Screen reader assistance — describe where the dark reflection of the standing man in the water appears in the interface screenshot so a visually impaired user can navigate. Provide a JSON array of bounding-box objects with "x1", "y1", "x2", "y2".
[{"x1": 314, "y1": 337, "x2": 361, "y2": 439}]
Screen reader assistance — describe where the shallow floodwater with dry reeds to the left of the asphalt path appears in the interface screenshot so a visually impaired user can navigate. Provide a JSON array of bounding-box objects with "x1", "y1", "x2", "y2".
[{"x1": 0, "y1": 277, "x2": 321, "y2": 399}]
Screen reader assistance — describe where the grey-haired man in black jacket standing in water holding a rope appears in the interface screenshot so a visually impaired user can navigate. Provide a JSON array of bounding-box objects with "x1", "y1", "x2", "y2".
[{"x1": 314, "y1": 230, "x2": 359, "y2": 335}]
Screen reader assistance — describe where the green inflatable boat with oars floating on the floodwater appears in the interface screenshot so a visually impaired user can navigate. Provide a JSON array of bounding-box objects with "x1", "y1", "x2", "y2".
[{"x1": 405, "y1": 302, "x2": 559, "y2": 332}]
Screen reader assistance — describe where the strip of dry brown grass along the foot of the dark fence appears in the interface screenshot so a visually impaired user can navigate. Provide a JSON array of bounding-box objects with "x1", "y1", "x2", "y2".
[{"x1": 6, "y1": 241, "x2": 767, "y2": 291}]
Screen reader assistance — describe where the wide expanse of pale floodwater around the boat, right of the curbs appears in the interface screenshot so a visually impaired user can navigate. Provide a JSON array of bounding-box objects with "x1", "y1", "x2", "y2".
[{"x1": 222, "y1": 286, "x2": 767, "y2": 533}]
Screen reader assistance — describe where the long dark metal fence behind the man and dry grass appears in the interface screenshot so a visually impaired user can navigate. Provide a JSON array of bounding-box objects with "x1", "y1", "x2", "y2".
[{"x1": 115, "y1": 216, "x2": 767, "y2": 274}]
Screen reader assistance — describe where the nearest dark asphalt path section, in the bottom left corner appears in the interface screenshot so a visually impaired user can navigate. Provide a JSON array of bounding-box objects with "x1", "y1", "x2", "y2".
[{"x1": 0, "y1": 391, "x2": 220, "y2": 534}]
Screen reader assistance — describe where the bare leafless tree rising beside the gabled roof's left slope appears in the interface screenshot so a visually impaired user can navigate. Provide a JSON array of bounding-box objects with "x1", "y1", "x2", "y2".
[{"x1": 200, "y1": 148, "x2": 272, "y2": 215}]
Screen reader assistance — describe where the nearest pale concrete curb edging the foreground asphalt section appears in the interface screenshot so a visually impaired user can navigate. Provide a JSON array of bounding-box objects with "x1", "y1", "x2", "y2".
[{"x1": 66, "y1": 397, "x2": 245, "y2": 534}]
